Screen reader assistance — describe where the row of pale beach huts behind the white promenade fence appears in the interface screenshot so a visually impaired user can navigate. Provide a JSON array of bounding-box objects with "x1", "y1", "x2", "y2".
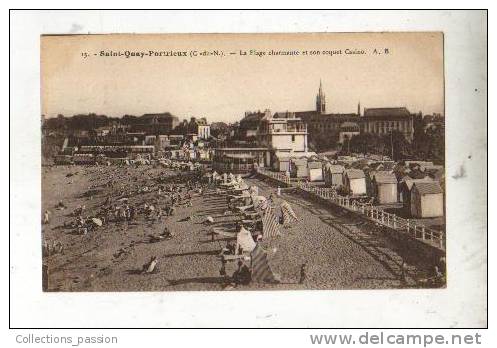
[{"x1": 273, "y1": 156, "x2": 445, "y2": 218}]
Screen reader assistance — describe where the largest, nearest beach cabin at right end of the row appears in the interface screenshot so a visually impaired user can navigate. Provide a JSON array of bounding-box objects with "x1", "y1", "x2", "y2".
[{"x1": 411, "y1": 182, "x2": 444, "y2": 218}]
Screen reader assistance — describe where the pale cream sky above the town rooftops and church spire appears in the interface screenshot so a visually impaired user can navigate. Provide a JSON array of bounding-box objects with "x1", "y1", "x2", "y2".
[{"x1": 41, "y1": 33, "x2": 444, "y2": 122}]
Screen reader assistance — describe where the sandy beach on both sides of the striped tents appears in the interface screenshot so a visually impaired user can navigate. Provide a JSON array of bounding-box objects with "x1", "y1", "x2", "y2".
[{"x1": 42, "y1": 166, "x2": 438, "y2": 291}]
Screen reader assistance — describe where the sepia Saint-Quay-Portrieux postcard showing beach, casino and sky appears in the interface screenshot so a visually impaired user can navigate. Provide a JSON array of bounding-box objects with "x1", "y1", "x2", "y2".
[{"x1": 40, "y1": 32, "x2": 450, "y2": 292}]
